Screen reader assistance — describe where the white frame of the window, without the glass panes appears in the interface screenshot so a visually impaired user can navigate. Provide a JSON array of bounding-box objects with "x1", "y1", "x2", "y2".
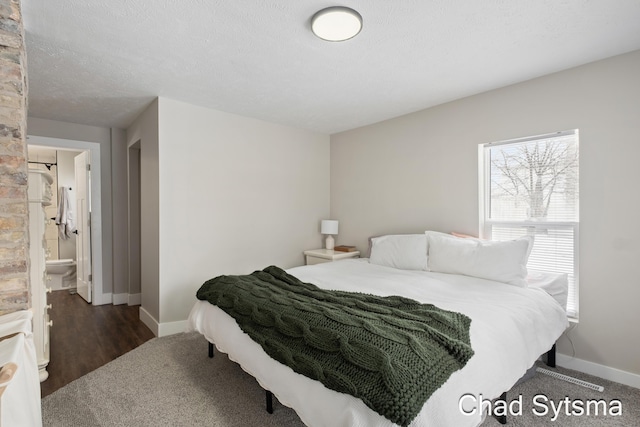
[{"x1": 478, "y1": 129, "x2": 580, "y2": 323}]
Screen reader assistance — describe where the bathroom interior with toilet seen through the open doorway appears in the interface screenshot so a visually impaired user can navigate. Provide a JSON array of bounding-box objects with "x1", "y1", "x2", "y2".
[{"x1": 28, "y1": 145, "x2": 80, "y2": 293}]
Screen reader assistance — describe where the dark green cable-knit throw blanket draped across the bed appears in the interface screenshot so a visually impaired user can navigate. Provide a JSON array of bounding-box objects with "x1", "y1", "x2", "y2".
[{"x1": 197, "y1": 266, "x2": 473, "y2": 426}]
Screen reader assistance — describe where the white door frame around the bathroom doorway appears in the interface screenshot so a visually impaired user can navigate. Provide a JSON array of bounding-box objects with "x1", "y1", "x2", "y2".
[{"x1": 27, "y1": 135, "x2": 105, "y2": 305}]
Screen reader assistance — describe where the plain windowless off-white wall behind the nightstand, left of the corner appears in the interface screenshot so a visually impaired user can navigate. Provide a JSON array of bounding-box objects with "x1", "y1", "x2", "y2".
[{"x1": 155, "y1": 98, "x2": 329, "y2": 335}]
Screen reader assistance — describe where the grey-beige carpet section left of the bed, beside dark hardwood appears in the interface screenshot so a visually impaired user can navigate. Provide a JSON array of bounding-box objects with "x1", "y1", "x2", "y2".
[{"x1": 42, "y1": 334, "x2": 303, "y2": 427}]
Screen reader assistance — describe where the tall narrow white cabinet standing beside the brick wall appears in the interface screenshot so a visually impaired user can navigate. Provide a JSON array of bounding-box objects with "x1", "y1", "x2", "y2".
[{"x1": 28, "y1": 169, "x2": 53, "y2": 381}]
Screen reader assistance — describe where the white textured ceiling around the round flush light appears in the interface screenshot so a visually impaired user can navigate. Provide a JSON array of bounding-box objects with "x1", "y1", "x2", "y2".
[{"x1": 22, "y1": 0, "x2": 640, "y2": 133}]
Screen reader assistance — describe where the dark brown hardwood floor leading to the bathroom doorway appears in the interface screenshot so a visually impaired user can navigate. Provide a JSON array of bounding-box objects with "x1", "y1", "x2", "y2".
[{"x1": 40, "y1": 291, "x2": 154, "y2": 397}]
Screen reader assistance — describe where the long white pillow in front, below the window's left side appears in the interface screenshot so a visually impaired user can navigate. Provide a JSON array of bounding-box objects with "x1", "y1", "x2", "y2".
[{"x1": 427, "y1": 234, "x2": 533, "y2": 287}]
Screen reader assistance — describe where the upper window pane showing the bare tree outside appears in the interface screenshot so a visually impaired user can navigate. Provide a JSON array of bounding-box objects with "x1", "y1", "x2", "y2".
[{"x1": 490, "y1": 136, "x2": 578, "y2": 221}]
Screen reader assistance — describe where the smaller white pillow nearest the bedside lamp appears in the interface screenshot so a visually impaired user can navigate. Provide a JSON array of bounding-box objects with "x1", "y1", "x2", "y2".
[{"x1": 369, "y1": 234, "x2": 427, "y2": 270}]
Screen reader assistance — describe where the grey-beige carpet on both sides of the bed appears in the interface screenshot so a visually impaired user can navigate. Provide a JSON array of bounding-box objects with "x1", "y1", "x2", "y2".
[{"x1": 42, "y1": 334, "x2": 640, "y2": 427}]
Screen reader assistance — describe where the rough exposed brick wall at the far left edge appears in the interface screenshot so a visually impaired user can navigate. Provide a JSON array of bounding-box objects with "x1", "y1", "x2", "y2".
[{"x1": 0, "y1": 0, "x2": 30, "y2": 314}]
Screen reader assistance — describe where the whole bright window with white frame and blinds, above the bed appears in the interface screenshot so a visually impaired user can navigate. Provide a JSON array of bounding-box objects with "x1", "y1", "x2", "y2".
[{"x1": 479, "y1": 129, "x2": 579, "y2": 319}]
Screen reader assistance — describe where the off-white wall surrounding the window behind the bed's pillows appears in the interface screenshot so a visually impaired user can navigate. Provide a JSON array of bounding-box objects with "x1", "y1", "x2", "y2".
[{"x1": 331, "y1": 51, "x2": 640, "y2": 378}]
